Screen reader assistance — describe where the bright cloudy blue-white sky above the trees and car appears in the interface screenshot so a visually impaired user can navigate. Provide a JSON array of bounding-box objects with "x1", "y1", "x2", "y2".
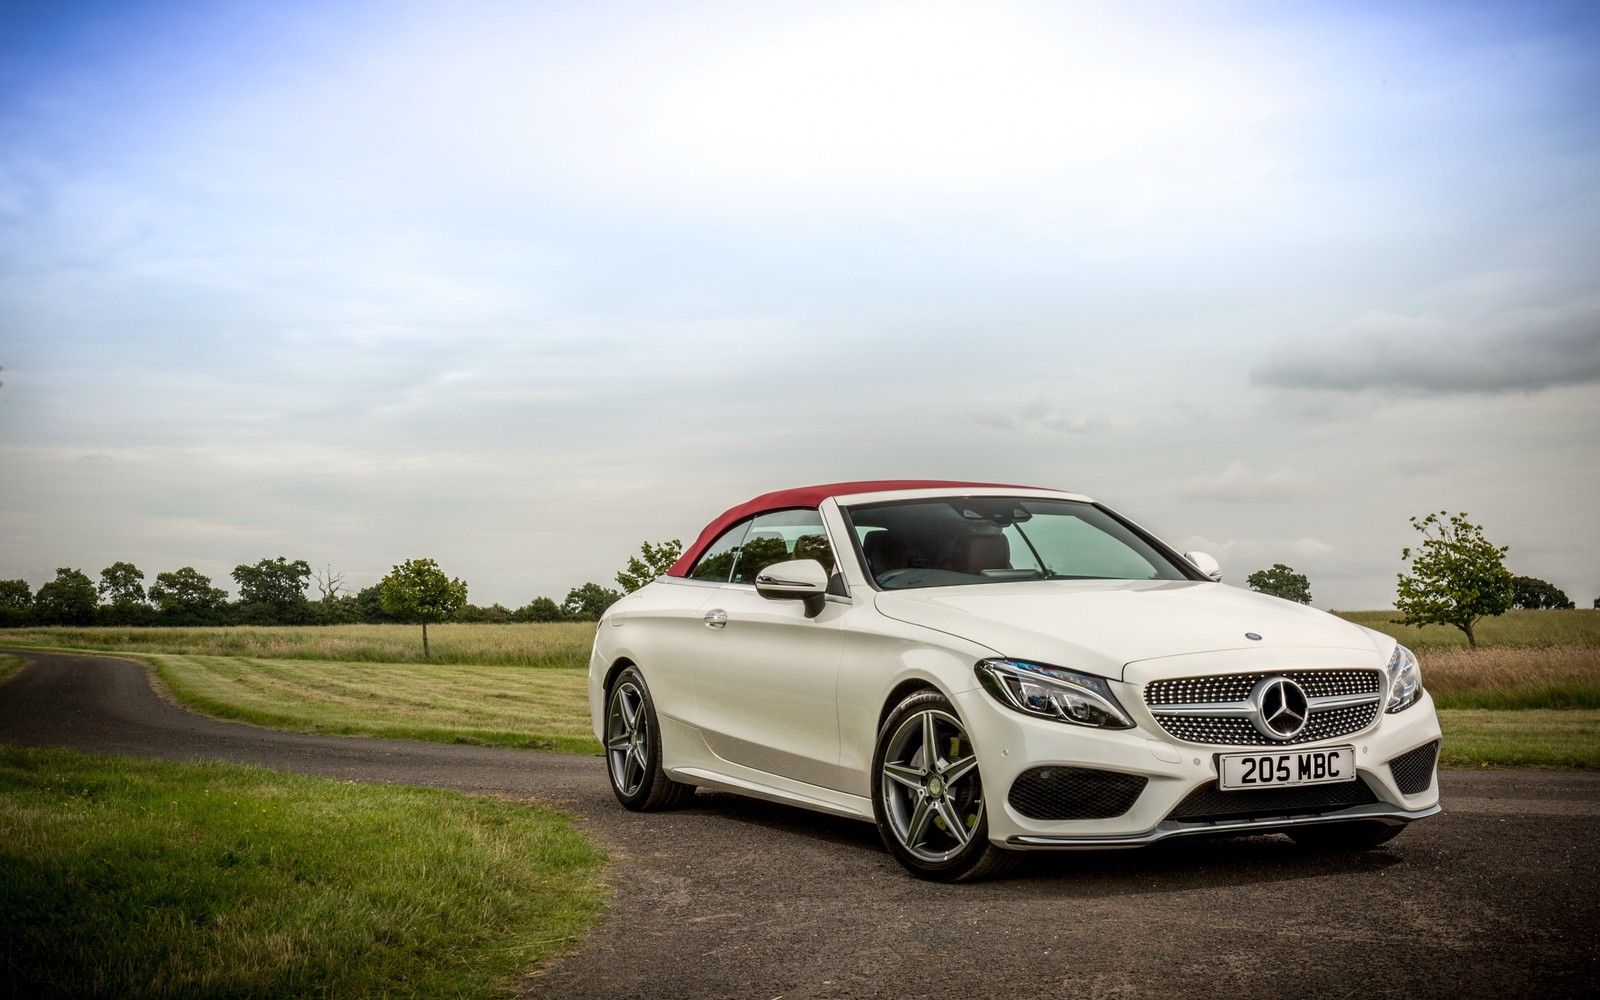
[{"x1": 0, "y1": 0, "x2": 1600, "y2": 610}]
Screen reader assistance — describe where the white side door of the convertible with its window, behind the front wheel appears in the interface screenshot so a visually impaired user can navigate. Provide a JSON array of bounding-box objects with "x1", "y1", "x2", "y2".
[{"x1": 691, "y1": 510, "x2": 850, "y2": 789}]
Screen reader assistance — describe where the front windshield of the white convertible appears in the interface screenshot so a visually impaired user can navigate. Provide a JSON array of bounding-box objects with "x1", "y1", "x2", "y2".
[{"x1": 845, "y1": 496, "x2": 1189, "y2": 590}]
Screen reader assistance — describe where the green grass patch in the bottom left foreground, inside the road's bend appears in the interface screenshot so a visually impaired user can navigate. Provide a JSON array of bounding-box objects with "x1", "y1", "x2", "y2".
[{"x1": 0, "y1": 747, "x2": 605, "y2": 997}]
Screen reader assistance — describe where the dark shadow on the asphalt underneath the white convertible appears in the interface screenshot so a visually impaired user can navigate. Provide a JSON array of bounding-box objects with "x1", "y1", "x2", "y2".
[{"x1": 683, "y1": 789, "x2": 1405, "y2": 899}]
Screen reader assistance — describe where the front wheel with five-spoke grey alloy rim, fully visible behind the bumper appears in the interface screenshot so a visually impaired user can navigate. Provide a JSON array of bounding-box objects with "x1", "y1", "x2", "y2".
[{"x1": 872, "y1": 691, "x2": 1019, "y2": 882}]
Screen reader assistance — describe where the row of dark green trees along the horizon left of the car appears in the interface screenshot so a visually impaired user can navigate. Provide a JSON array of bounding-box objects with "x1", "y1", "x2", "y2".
[{"x1": 0, "y1": 539, "x2": 683, "y2": 624}]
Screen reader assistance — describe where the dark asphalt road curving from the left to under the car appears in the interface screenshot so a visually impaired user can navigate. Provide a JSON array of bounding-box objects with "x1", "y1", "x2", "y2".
[{"x1": 0, "y1": 653, "x2": 1600, "y2": 1000}]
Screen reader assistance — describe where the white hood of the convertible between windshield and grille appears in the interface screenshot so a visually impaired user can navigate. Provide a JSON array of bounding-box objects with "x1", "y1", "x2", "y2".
[{"x1": 875, "y1": 579, "x2": 1387, "y2": 680}]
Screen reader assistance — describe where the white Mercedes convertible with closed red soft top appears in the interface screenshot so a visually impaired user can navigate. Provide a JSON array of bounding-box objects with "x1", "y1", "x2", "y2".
[{"x1": 589, "y1": 482, "x2": 1438, "y2": 880}]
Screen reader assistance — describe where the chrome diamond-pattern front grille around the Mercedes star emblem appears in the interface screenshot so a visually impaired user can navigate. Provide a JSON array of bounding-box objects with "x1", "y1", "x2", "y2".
[{"x1": 1144, "y1": 670, "x2": 1384, "y2": 747}]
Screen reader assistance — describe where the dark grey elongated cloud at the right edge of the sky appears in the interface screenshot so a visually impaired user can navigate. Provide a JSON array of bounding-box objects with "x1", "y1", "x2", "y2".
[{"x1": 1251, "y1": 301, "x2": 1600, "y2": 394}]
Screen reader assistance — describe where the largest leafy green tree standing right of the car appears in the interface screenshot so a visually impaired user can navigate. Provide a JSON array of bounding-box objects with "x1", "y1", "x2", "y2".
[{"x1": 1395, "y1": 510, "x2": 1512, "y2": 650}]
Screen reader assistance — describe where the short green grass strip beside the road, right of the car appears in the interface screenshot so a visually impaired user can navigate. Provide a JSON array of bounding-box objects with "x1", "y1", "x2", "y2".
[{"x1": 1438, "y1": 709, "x2": 1600, "y2": 770}]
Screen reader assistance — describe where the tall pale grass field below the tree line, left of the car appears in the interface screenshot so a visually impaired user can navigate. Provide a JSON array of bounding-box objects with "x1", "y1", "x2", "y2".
[{"x1": 0, "y1": 622, "x2": 595, "y2": 669}]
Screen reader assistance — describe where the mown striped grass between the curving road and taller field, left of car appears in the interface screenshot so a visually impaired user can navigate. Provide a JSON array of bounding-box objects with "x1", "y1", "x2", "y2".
[{"x1": 148, "y1": 654, "x2": 600, "y2": 754}]
